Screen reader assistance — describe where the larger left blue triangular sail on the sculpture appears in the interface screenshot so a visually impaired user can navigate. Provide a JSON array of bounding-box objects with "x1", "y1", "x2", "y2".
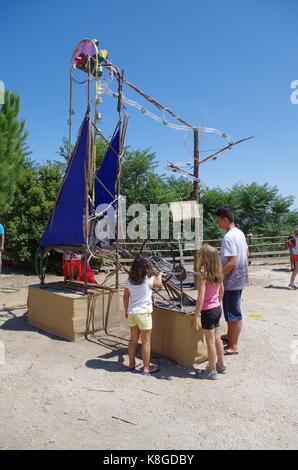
[{"x1": 40, "y1": 111, "x2": 91, "y2": 247}]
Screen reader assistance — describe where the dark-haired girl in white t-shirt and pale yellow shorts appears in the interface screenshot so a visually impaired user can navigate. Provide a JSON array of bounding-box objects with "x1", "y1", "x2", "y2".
[{"x1": 123, "y1": 255, "x2": 162, "y2": 375}]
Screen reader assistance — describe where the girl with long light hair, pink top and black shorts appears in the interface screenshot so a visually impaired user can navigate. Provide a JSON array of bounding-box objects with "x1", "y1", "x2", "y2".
[{"x1": 194, "y1": 245, "x2": 226, "y2": 380}]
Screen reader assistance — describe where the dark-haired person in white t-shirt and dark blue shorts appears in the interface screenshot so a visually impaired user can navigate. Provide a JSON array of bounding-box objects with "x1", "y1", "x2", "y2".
[{"x1": 215, "y1": 206, "x2": 248, "y2": 355}]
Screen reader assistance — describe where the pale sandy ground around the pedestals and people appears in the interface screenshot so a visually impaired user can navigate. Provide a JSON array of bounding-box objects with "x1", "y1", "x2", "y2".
[{"x1": 0, "y1": 260, "x2": 298, "y2": 450}]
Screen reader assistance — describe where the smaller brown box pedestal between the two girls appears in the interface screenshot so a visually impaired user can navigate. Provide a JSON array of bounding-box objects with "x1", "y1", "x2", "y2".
[{"x1": 151, "y1": 307, "x2": 208, "y2": 367}]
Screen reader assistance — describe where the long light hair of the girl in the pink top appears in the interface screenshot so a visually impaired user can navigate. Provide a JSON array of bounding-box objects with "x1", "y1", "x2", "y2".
[{"x1": 198, "y1": 244, "x2": 223, "y2": 285}]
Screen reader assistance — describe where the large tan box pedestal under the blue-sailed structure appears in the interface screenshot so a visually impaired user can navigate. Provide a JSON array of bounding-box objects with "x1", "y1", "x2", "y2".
[{"x1": 28, "y1": 282, "x2": 120, "y2": 341}]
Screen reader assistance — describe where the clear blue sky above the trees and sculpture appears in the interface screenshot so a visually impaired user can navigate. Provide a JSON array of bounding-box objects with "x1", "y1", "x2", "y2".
[{"x1": 0, "y1": 0, "x2": 298, "y2": 208}]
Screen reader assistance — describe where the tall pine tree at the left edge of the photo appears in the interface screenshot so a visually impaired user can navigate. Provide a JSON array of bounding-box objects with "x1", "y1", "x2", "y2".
[{"x1": 0, "y1": 90, "x2": 30, "y2": 214}]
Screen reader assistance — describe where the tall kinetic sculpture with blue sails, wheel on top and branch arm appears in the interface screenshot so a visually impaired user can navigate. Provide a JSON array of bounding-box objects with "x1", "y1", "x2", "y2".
[{"x1": 40, "y1": 39, "x2": 251, "y2": 311}]
